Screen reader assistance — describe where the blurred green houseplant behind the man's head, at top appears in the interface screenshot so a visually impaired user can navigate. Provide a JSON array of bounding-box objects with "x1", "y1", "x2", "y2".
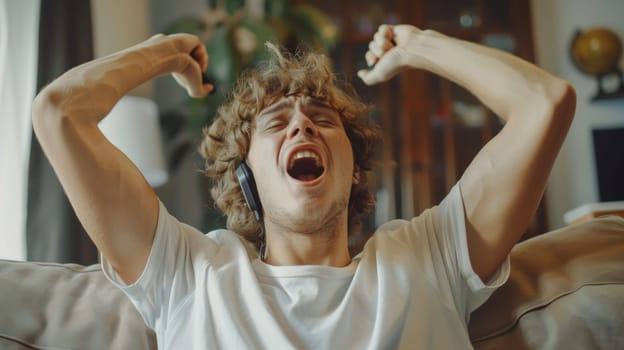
[{"x1": 165, "y1": 0, "x2": 338, "y2": 133}]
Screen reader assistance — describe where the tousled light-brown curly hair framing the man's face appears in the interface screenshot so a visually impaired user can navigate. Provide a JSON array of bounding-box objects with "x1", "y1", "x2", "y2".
[{"x1": 200, "y1": 43, "x2": 379, "y2": 243}]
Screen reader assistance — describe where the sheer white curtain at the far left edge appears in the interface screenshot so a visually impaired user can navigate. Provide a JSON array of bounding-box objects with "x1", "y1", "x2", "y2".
[{"x1": 0, "y1": 0, "x2": 39, "y2": 260}]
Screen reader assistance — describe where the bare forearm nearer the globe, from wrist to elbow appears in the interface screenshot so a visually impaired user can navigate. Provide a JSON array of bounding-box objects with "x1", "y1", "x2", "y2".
[{"x1": 405, "y1": 31, "x2": 568, "y2": 119}]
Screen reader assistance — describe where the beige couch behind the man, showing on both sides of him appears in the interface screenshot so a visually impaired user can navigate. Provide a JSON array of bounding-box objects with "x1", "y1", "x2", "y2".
[{"x1": 0, "y1": 217, "x2": 624, "y2": 350}]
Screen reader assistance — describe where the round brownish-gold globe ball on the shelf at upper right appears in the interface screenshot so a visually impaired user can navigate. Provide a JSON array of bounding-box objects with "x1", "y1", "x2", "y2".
[{"x1": 571, "y1": 28, "x2": 622, "y2": 76}]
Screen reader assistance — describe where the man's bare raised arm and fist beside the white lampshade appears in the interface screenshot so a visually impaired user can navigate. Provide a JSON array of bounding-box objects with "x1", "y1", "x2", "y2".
[{"x1": 33, "y1": 34, "x2": 212, "y2": 283}]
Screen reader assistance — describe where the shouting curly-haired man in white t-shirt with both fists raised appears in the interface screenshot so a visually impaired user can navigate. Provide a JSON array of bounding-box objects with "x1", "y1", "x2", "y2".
[{"x1": 33, "y1": 25, "x2": 575, "y2": 349}]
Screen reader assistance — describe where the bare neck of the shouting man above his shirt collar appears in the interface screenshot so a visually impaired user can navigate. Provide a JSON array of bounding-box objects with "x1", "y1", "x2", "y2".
[{"x1": 265, "y1": 216, "x2": 351, "y2": 267}]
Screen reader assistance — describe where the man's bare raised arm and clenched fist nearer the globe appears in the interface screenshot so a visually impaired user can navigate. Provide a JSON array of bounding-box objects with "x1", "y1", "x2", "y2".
[{"x1": 359, "y1": 25, "x2": 576, "y2": 279}]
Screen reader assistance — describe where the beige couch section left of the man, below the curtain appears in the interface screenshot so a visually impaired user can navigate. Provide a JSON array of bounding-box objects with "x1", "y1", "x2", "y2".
[{"x1": 0, "y1": 260, "x2": 156, "y2": 349}]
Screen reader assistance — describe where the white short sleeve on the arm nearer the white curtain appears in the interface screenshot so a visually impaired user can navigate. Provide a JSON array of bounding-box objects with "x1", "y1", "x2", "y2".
[{"x1": 101, "y1": 202, "x2": 214, "y2": 329}]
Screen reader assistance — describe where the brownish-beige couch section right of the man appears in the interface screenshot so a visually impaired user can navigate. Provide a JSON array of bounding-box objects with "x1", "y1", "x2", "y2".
[{"x1": 469, "y1": 217, "x2": 624, "y2": 350}]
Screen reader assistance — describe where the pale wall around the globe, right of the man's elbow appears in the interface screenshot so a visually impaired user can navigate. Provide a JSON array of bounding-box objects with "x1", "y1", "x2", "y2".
[{"x1": 531, "y1": 0, "x2": 624, "y2": 228}]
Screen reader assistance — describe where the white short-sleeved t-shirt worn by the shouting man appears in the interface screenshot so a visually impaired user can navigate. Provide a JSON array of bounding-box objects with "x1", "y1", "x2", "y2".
[{"x1": 102, "y1": 186, "x2": 509, "y2": 349}]
